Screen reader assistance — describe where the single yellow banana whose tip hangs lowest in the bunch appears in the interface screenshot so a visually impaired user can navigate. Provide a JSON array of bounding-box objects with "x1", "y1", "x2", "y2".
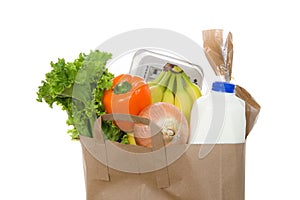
[{"x1": 175, "y1": 74, "x2": 193, "y2": 122}]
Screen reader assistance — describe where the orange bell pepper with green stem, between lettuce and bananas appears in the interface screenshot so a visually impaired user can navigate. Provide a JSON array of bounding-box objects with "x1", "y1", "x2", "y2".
[{"x1": 103, "y1": 74, "x2": 151, "y2": 132}]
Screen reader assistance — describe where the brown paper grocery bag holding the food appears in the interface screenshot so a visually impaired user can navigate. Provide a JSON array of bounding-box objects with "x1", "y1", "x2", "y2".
[{"x1": 80, "y1": 116, "x2": 245, "y2": 200}]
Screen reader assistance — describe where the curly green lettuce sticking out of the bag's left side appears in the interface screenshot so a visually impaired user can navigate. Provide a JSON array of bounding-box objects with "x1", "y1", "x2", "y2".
[{"x1": 37, "y1": 50, "x2": 124, "y2": 141}]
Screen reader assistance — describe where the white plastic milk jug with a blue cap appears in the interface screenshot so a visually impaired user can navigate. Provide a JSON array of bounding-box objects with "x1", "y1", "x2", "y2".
[{"x1": 189, "y1": 81, "x2": 246, "y2": 144}]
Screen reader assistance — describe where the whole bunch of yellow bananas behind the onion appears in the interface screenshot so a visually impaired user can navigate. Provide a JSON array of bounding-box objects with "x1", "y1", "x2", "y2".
[{"x1": 148, "y1": 65, "x2": 202, "y2": 122}]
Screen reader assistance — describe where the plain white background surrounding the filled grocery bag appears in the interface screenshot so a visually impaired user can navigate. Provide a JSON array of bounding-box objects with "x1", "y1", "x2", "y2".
[{"x1": 0, "y1": 0, "x2": 300, "y2": 200}]
